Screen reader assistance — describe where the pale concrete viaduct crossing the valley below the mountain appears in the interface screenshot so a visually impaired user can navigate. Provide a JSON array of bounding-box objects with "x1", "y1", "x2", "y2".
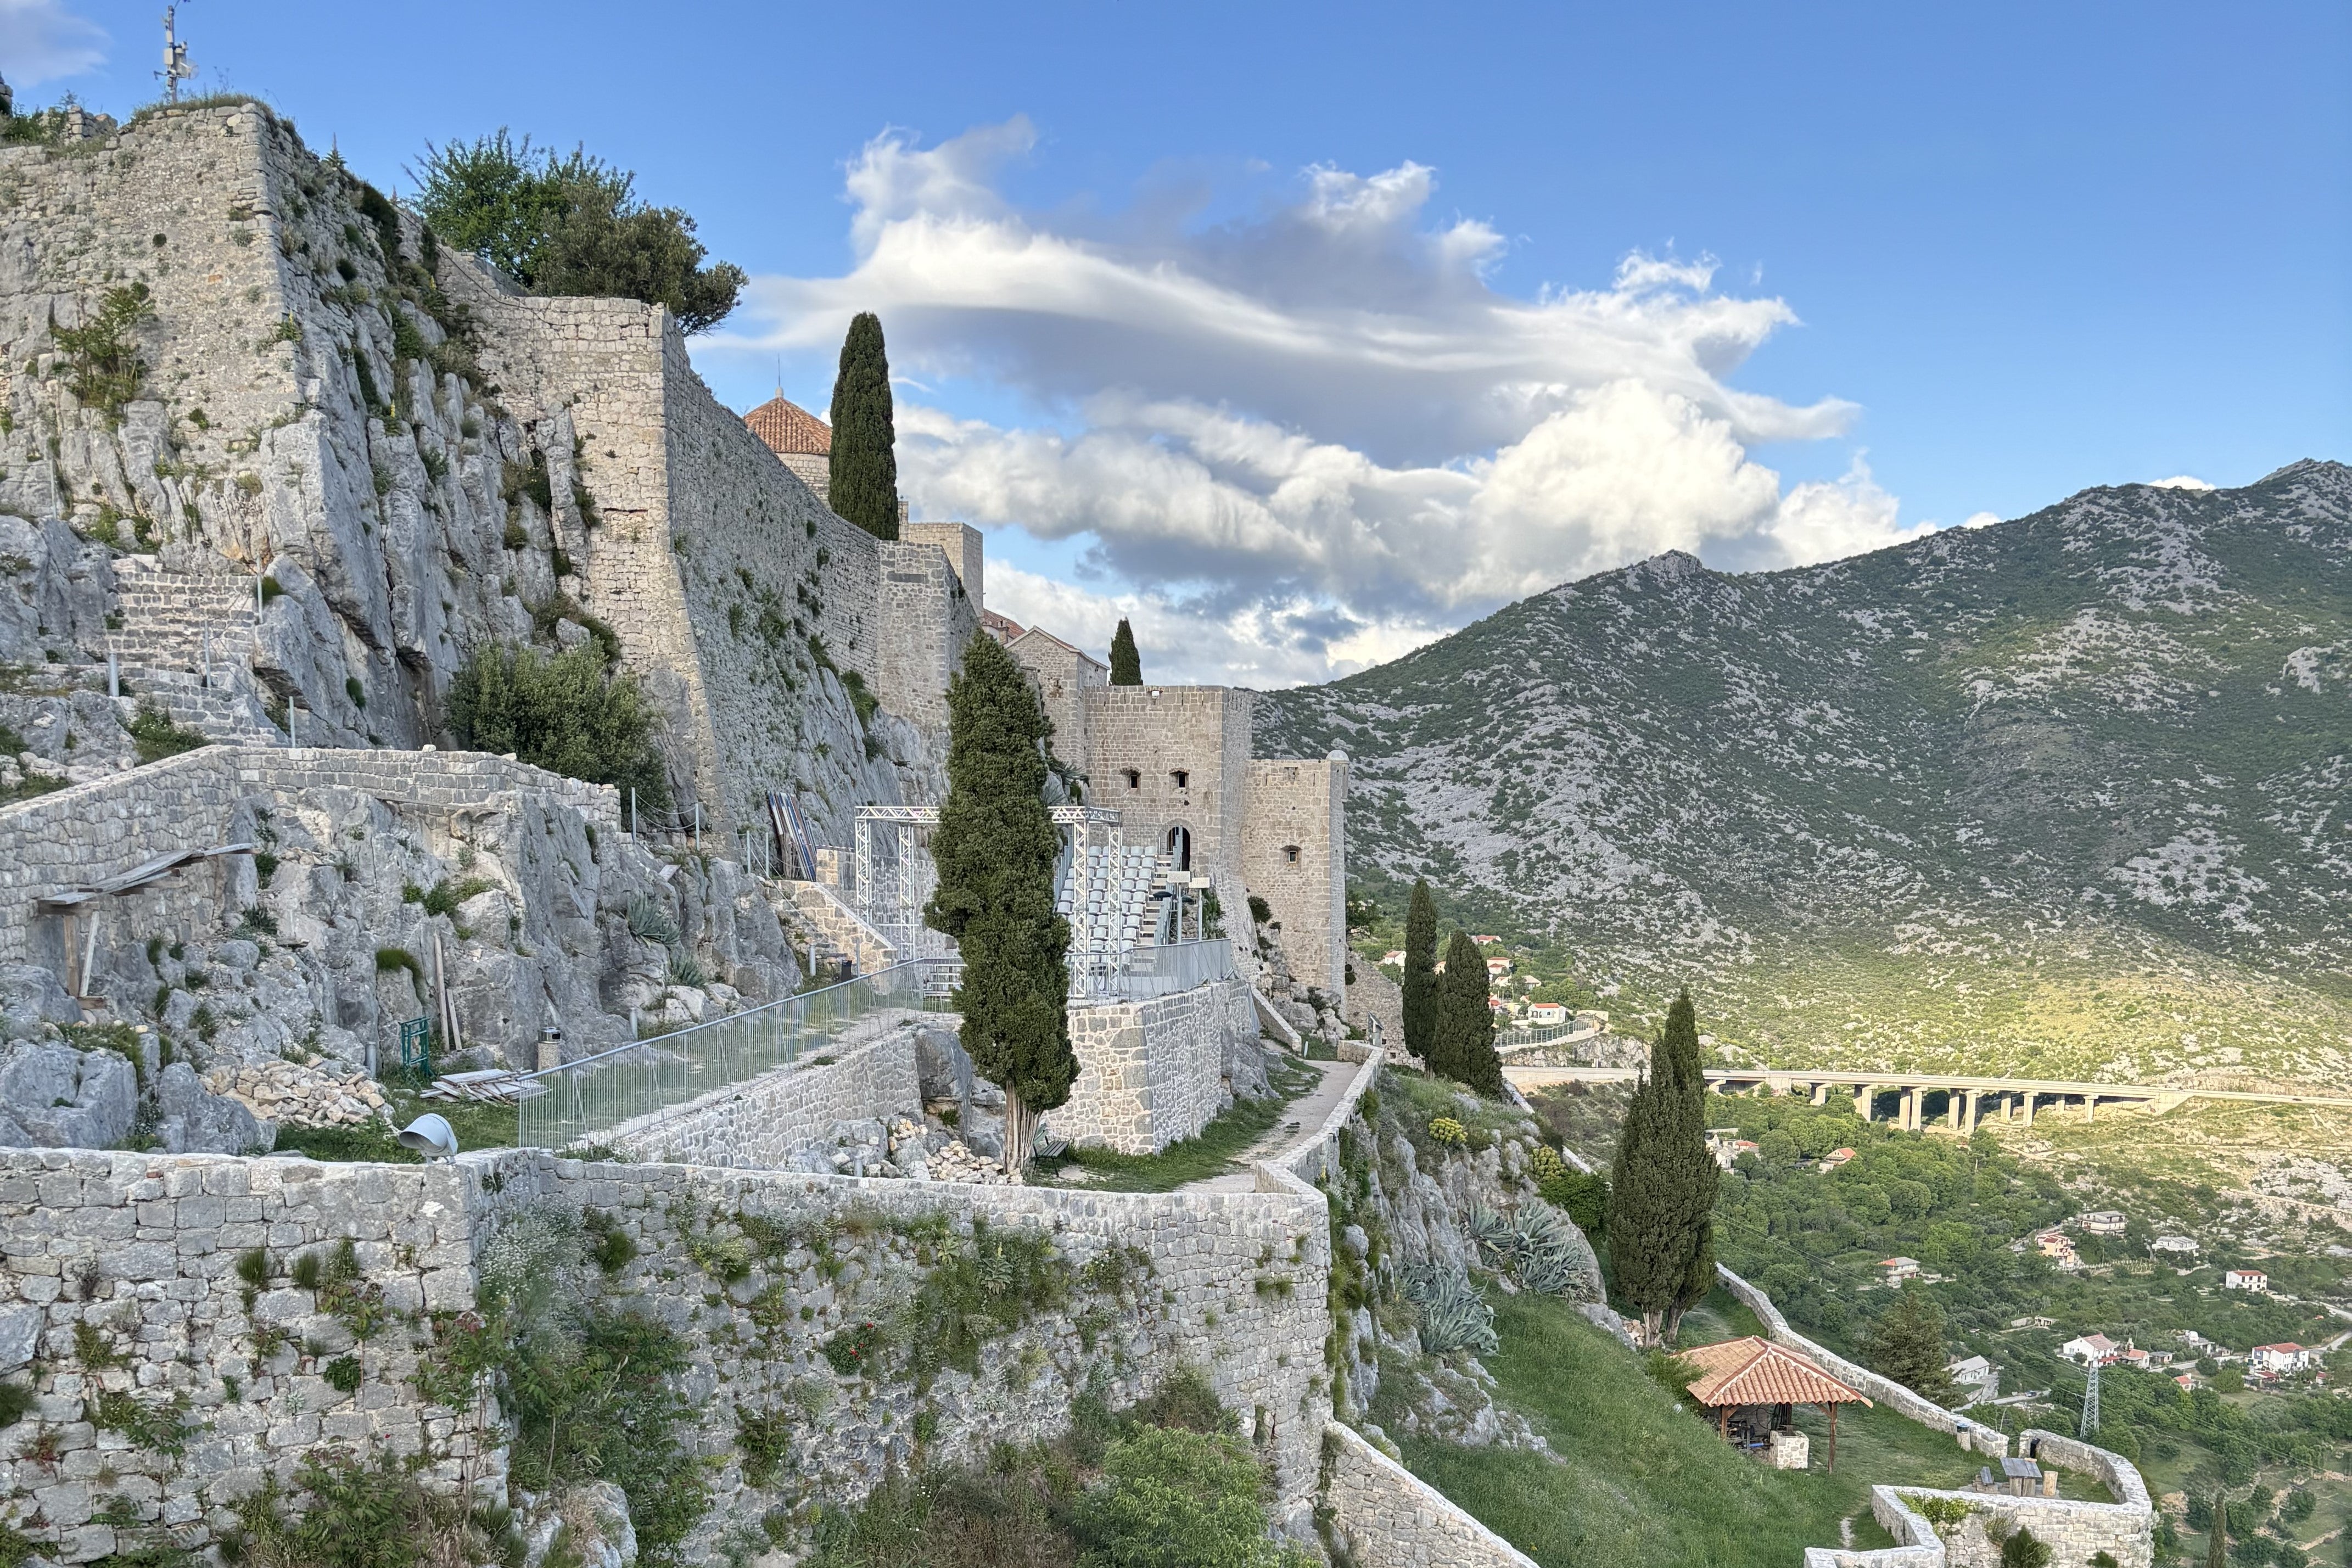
[{"x1": 1503, "y1": 1067, "x2": 2352, "y2": 1135}]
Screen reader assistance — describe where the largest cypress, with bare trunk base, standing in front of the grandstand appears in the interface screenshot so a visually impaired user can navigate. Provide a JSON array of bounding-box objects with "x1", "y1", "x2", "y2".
[{"x1": 922, "y1": 637, "x2": 1077, "y2": 1173}]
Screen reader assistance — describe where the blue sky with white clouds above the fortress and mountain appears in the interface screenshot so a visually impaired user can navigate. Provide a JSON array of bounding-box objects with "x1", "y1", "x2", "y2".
[{"x1": 0, "y1": 0, "x2": 2352, "y2": 684}]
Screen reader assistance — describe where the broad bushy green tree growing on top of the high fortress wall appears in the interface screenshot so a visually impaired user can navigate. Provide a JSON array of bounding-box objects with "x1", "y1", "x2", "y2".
[{"x1": 409, "y1": 127, "x2": 746, "y2": 336}]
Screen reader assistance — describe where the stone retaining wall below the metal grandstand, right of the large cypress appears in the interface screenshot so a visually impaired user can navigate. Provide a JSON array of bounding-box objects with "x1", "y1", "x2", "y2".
[{"x1": 1044, "y1": 978, "x2": 1258, "y2": 1154}]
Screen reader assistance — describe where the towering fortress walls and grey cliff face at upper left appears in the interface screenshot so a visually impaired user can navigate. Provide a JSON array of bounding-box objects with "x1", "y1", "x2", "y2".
[{"x1": 0, "y1": 106, "x2": 941, "y2": 835}]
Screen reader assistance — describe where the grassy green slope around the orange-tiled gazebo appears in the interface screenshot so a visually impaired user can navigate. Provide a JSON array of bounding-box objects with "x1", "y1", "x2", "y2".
[{"x1": 1399, "y1": 1295, "x2": 1980, "y2": 1568}]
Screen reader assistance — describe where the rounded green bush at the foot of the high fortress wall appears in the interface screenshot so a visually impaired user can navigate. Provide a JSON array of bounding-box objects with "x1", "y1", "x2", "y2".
[{"x1": 449, "y1": 647, "x2": 670, "y2": 811}]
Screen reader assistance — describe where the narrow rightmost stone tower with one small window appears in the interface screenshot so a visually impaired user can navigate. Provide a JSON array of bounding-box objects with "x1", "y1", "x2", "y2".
[{"x1": 1242, "y1": 752, "x2": 1348, "y2": 1016}]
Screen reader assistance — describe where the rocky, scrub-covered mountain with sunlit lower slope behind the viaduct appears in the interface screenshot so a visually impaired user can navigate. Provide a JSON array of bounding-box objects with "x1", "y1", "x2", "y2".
[{"x1": 1258, "y1": 461, "x2": 2352, "y2": 1084}]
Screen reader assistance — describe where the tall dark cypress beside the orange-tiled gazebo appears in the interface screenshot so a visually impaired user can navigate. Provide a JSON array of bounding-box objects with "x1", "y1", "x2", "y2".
[{"x1": 1609, "y1": 1001, "x2": 1722, "y2": 1342}]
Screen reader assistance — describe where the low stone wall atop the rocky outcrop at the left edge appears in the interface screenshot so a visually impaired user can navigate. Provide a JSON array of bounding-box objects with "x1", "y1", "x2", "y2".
[{"x1": 0, "y1": 745, "x2": 619, "y2": 964}]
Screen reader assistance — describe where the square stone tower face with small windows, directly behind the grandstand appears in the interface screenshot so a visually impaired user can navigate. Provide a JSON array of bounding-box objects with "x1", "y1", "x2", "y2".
[{"x1": 1084, "y1": 686, "x2": 1251, "y2": 882}]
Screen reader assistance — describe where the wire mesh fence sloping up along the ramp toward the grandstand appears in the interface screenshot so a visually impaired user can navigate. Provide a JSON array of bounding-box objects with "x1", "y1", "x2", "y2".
[{"x1": 515, "y1": 959, "x2": 943, "y2": 1150}]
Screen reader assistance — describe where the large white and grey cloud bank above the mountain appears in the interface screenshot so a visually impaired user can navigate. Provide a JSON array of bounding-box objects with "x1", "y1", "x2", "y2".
[{"x1": 703, "y1": 120, "x2": 1931, "y2": 684}]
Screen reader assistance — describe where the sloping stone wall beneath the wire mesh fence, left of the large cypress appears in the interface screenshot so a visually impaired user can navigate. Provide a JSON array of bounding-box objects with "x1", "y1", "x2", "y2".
[{"x1": 600, "y1": 1013, "x2": 938, "y2": 1171}]
